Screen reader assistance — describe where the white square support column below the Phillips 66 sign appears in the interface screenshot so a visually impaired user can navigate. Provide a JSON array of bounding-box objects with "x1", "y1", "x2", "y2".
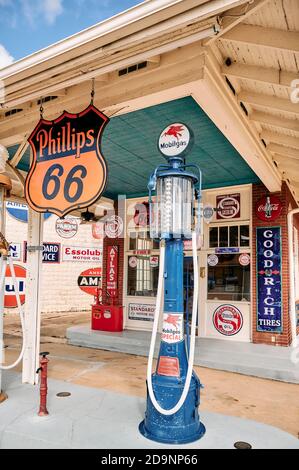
[{"x1": 22, "y1": 207, "x2": 44, "y2": 385}]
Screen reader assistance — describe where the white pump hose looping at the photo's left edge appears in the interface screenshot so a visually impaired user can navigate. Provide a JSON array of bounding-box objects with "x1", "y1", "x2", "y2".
[{"x1": 0, "y1": 232, "x2": 26, "y2": 370}]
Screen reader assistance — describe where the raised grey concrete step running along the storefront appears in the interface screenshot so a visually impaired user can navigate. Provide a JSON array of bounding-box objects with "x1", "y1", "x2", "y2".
[{"x1": 66, "y1": 324, "x2": 299, "y2": 384}]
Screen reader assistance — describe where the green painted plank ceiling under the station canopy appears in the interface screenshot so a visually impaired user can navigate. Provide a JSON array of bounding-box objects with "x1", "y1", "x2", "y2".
[{"x1": 9, "y1": 97, "x2": 259, "y2": 198}]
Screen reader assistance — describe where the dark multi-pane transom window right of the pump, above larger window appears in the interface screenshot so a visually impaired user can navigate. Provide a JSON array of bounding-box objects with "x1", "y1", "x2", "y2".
[{"x1": 209, "y1": 225, "x2": 250, "y2": 248}]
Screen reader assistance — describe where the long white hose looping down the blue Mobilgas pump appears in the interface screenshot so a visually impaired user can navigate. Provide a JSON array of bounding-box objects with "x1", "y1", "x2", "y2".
[{"x1": 147, "y1": 232, "x2": 198, "y2": 416}]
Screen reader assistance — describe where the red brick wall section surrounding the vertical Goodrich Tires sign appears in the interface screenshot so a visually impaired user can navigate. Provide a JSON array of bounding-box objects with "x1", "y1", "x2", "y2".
[{"x1": 252, "y1": 183, "x2": 299, "y2": 346}]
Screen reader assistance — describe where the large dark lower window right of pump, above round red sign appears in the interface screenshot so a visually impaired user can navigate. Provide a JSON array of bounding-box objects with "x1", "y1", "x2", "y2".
[{"x1": 208, "y1": 254, "x2": 250, "y2": 302}]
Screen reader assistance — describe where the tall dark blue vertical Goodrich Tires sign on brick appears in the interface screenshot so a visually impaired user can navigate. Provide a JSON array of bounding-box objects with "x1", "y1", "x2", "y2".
[{"x1": 256, "y1": 227, "x2": 282, "y2": 333}]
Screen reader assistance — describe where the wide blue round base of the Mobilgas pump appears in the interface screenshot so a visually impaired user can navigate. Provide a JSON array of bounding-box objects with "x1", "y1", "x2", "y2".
[{"x1": 139, "y1": 373, "x2": 206, "y2": 444}]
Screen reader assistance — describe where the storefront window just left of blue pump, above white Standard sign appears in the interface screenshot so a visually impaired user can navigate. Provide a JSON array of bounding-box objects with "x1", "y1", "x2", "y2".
[{"x1": 127, "y1": 256, "x2": 159, "y2": 297}]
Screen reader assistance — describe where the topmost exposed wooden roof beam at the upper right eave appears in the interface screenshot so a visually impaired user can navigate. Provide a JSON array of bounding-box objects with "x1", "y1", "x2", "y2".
[{"x1": 221, "y1": 24, "x2": 299, "y2": 54}]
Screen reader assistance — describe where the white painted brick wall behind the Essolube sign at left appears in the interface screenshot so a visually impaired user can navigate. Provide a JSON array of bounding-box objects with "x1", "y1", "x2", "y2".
[{"x1": 5, "y1": 211, "x2": 102, "y2": 312}]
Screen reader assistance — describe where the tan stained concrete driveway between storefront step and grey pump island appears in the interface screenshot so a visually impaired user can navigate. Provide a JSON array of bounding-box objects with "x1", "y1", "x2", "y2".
[{"x1": 0, "y1": 314, "x2": 299, "y2": 442}]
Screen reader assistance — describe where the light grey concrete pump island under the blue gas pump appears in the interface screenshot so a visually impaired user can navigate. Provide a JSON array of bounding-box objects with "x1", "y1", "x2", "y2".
[{"x1": 0, "y1": 372, "x2": 299, "y2": 449}]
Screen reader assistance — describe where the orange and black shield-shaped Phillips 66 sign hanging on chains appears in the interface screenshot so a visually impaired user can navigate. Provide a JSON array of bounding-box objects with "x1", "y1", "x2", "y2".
[{"x1": 25, "y1": 104, "x2": 109, "y2": 217}]
